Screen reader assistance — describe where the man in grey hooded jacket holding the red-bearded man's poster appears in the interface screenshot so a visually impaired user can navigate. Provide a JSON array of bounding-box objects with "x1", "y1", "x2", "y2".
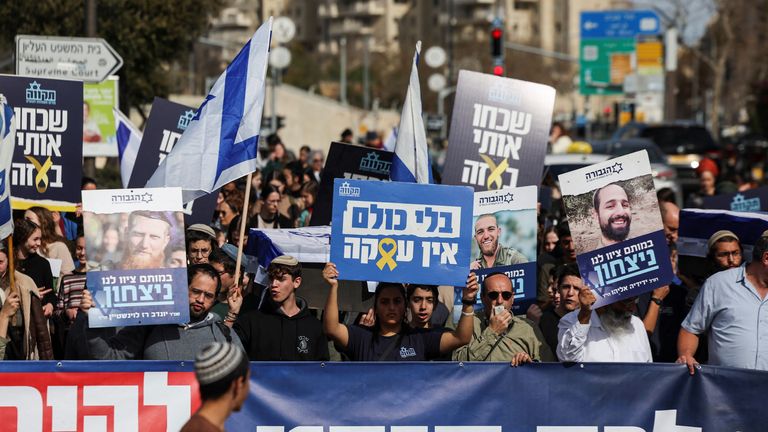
[{"x1": 72, "y1": 264, "x2": 242, "y2": 360}]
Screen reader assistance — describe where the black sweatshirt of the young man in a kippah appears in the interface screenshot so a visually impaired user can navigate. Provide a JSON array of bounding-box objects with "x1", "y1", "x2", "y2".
[{"x1": 234, "y1": 298, "x2": 329, "y2": 361}]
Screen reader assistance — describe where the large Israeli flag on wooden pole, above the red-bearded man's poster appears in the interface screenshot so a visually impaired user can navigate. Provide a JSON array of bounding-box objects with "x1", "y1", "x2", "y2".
[{"x1": 146, "y1": 18, "x2": 272, "y2": 203}]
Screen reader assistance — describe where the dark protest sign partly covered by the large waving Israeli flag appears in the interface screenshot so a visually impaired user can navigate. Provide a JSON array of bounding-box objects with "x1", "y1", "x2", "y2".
[{"x1": 128, "y1": 98, "x2": 219, "y2": 225}]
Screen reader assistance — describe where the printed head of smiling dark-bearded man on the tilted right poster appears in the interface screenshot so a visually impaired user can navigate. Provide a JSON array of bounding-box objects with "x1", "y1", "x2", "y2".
[{"x1": 592, "y1": 183, "x2": 632, "y2": 249}]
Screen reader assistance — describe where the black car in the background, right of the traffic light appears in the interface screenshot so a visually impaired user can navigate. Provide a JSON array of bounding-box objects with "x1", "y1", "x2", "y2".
[{"x1": 611, "y1": 122, "x2": 722, "y2": 194}]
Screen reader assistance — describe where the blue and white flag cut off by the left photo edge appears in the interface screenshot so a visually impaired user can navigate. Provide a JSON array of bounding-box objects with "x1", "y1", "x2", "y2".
[{"x1": 0, "y1": 94, "x2": 16, "y2": 239}]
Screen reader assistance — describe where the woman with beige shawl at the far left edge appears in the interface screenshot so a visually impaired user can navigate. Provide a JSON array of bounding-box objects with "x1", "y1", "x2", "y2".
[{"x1": 0, "y1": 241, "x2": 53, "y2": 360}]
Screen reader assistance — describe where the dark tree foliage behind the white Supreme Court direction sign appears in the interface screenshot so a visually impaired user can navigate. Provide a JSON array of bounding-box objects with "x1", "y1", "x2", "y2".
[{"x1": 0, "y1": 0, "x2": 223, "y2": 119}]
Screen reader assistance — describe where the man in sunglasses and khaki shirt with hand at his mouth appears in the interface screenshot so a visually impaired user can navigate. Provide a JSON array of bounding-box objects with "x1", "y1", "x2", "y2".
[{"x1": 452, "y1": 273, "x2": 554, "y2": 366}]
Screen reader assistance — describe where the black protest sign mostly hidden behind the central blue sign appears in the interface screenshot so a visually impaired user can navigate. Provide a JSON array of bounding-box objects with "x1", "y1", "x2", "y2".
[{"x1": 309, "y1": 142, "x2": 392, "y2": 226}]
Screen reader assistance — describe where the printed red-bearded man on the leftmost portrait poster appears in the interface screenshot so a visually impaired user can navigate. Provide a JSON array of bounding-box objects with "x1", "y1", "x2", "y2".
[{"x1": 120, "y1": 211, "x2": 171, "y2": 270}]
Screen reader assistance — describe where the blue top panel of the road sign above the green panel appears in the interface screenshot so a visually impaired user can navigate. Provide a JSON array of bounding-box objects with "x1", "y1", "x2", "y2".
[{"x1": 580, "y1": 10, "x2": 661, "y2": 39}]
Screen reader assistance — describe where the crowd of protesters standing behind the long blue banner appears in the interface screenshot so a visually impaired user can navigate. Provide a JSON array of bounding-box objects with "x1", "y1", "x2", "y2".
[{"x1": 0, "y1": 131, "x2": 768, "y2": 373}]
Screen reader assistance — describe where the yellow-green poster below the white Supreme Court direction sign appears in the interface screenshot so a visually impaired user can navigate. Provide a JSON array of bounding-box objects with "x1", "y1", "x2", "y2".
[{"x1": 83, "y1": 76, "x2": 119, "y2": 157}]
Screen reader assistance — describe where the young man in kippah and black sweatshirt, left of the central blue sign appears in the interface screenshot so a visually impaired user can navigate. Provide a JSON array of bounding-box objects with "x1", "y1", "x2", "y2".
[{"x1": 234, "y1": 255, "x2": 328, "y2": 361}]
